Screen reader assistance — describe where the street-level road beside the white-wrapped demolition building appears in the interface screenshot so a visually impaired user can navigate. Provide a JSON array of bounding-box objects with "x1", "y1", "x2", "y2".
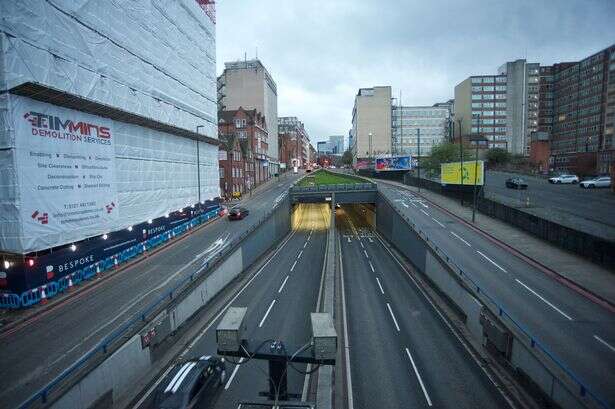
[{"x1": 0, "y1": 175, "x2": 300, "y2": 407}]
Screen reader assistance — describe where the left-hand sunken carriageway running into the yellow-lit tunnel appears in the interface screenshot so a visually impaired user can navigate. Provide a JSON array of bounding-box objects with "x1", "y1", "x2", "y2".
[{"x1": 134, "y1": 204, "x2": 330, "y2": 409}]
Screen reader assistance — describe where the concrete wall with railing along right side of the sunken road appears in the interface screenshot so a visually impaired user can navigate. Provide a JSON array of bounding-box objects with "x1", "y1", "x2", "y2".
[{"x1": 376, "y1": 194, "x2": 610, "y2": 409}]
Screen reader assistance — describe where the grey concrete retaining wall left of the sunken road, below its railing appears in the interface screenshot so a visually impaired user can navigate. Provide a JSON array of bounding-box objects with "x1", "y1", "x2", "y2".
[{"x1": 51, "y1": 196, "x2": 291, "y2": 409}]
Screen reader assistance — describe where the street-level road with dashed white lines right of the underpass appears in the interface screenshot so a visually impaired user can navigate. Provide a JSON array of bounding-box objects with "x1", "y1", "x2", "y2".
[{"x1": 378, "y1": 182, "x2": 615, "y2": 407}]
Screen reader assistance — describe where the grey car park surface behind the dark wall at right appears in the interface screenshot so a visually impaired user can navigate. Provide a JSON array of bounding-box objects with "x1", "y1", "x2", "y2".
[{"x1": 484, "y1": 171, "x2": 615, "y2": 241}]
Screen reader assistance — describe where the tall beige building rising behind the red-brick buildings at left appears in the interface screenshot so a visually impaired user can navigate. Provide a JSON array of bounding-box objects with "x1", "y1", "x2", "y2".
[{"x1": 218, "y1": 59, "x2": 278, "y2": 174}]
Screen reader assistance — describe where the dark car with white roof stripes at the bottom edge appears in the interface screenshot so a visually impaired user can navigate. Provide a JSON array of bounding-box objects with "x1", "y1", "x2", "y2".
[{"x1": 154, "y1": 355, "x2": 226, "y2": 409}]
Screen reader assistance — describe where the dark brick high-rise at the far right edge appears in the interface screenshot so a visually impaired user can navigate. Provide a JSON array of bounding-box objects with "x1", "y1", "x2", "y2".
[{"x1": 549, "y1": 45, "x2": 615, "y2": 174}]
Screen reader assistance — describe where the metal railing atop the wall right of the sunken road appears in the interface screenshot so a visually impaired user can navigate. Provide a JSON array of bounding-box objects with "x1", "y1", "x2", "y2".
[{"x1": 380, "y1": 194, "x2": 611, "y2": 409}]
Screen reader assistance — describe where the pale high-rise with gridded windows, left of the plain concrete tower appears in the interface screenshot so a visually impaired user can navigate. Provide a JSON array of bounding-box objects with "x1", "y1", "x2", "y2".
[{"x1": 454, "y1": 75, "x2": 513, "y2": 151}]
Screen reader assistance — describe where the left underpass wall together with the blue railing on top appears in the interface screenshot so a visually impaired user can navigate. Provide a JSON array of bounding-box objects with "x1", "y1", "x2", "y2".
[{"x1": 19, "y1": 194, "x2": 291, "y2": 409}]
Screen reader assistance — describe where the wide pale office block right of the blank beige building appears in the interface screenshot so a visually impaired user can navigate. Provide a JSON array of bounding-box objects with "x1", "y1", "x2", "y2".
[{"x1": 392, "y1": 105, "x2": 450, "y2": 156}]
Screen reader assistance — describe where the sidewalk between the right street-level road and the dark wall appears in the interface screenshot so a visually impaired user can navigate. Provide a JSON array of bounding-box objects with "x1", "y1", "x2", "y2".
[{"x1": 373, "y1": 179, "x2": 615, "y2": 303}]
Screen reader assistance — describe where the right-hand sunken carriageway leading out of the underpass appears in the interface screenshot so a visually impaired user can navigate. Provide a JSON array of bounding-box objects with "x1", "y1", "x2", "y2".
[{"x1": 336, "y1": 206, "x2": 508, "y2": 409}]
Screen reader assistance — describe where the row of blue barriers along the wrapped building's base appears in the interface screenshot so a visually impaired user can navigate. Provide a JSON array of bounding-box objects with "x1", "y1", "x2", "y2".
[{"x1": 0, "y1": 207, "x2": 220, "y2": 309}]
